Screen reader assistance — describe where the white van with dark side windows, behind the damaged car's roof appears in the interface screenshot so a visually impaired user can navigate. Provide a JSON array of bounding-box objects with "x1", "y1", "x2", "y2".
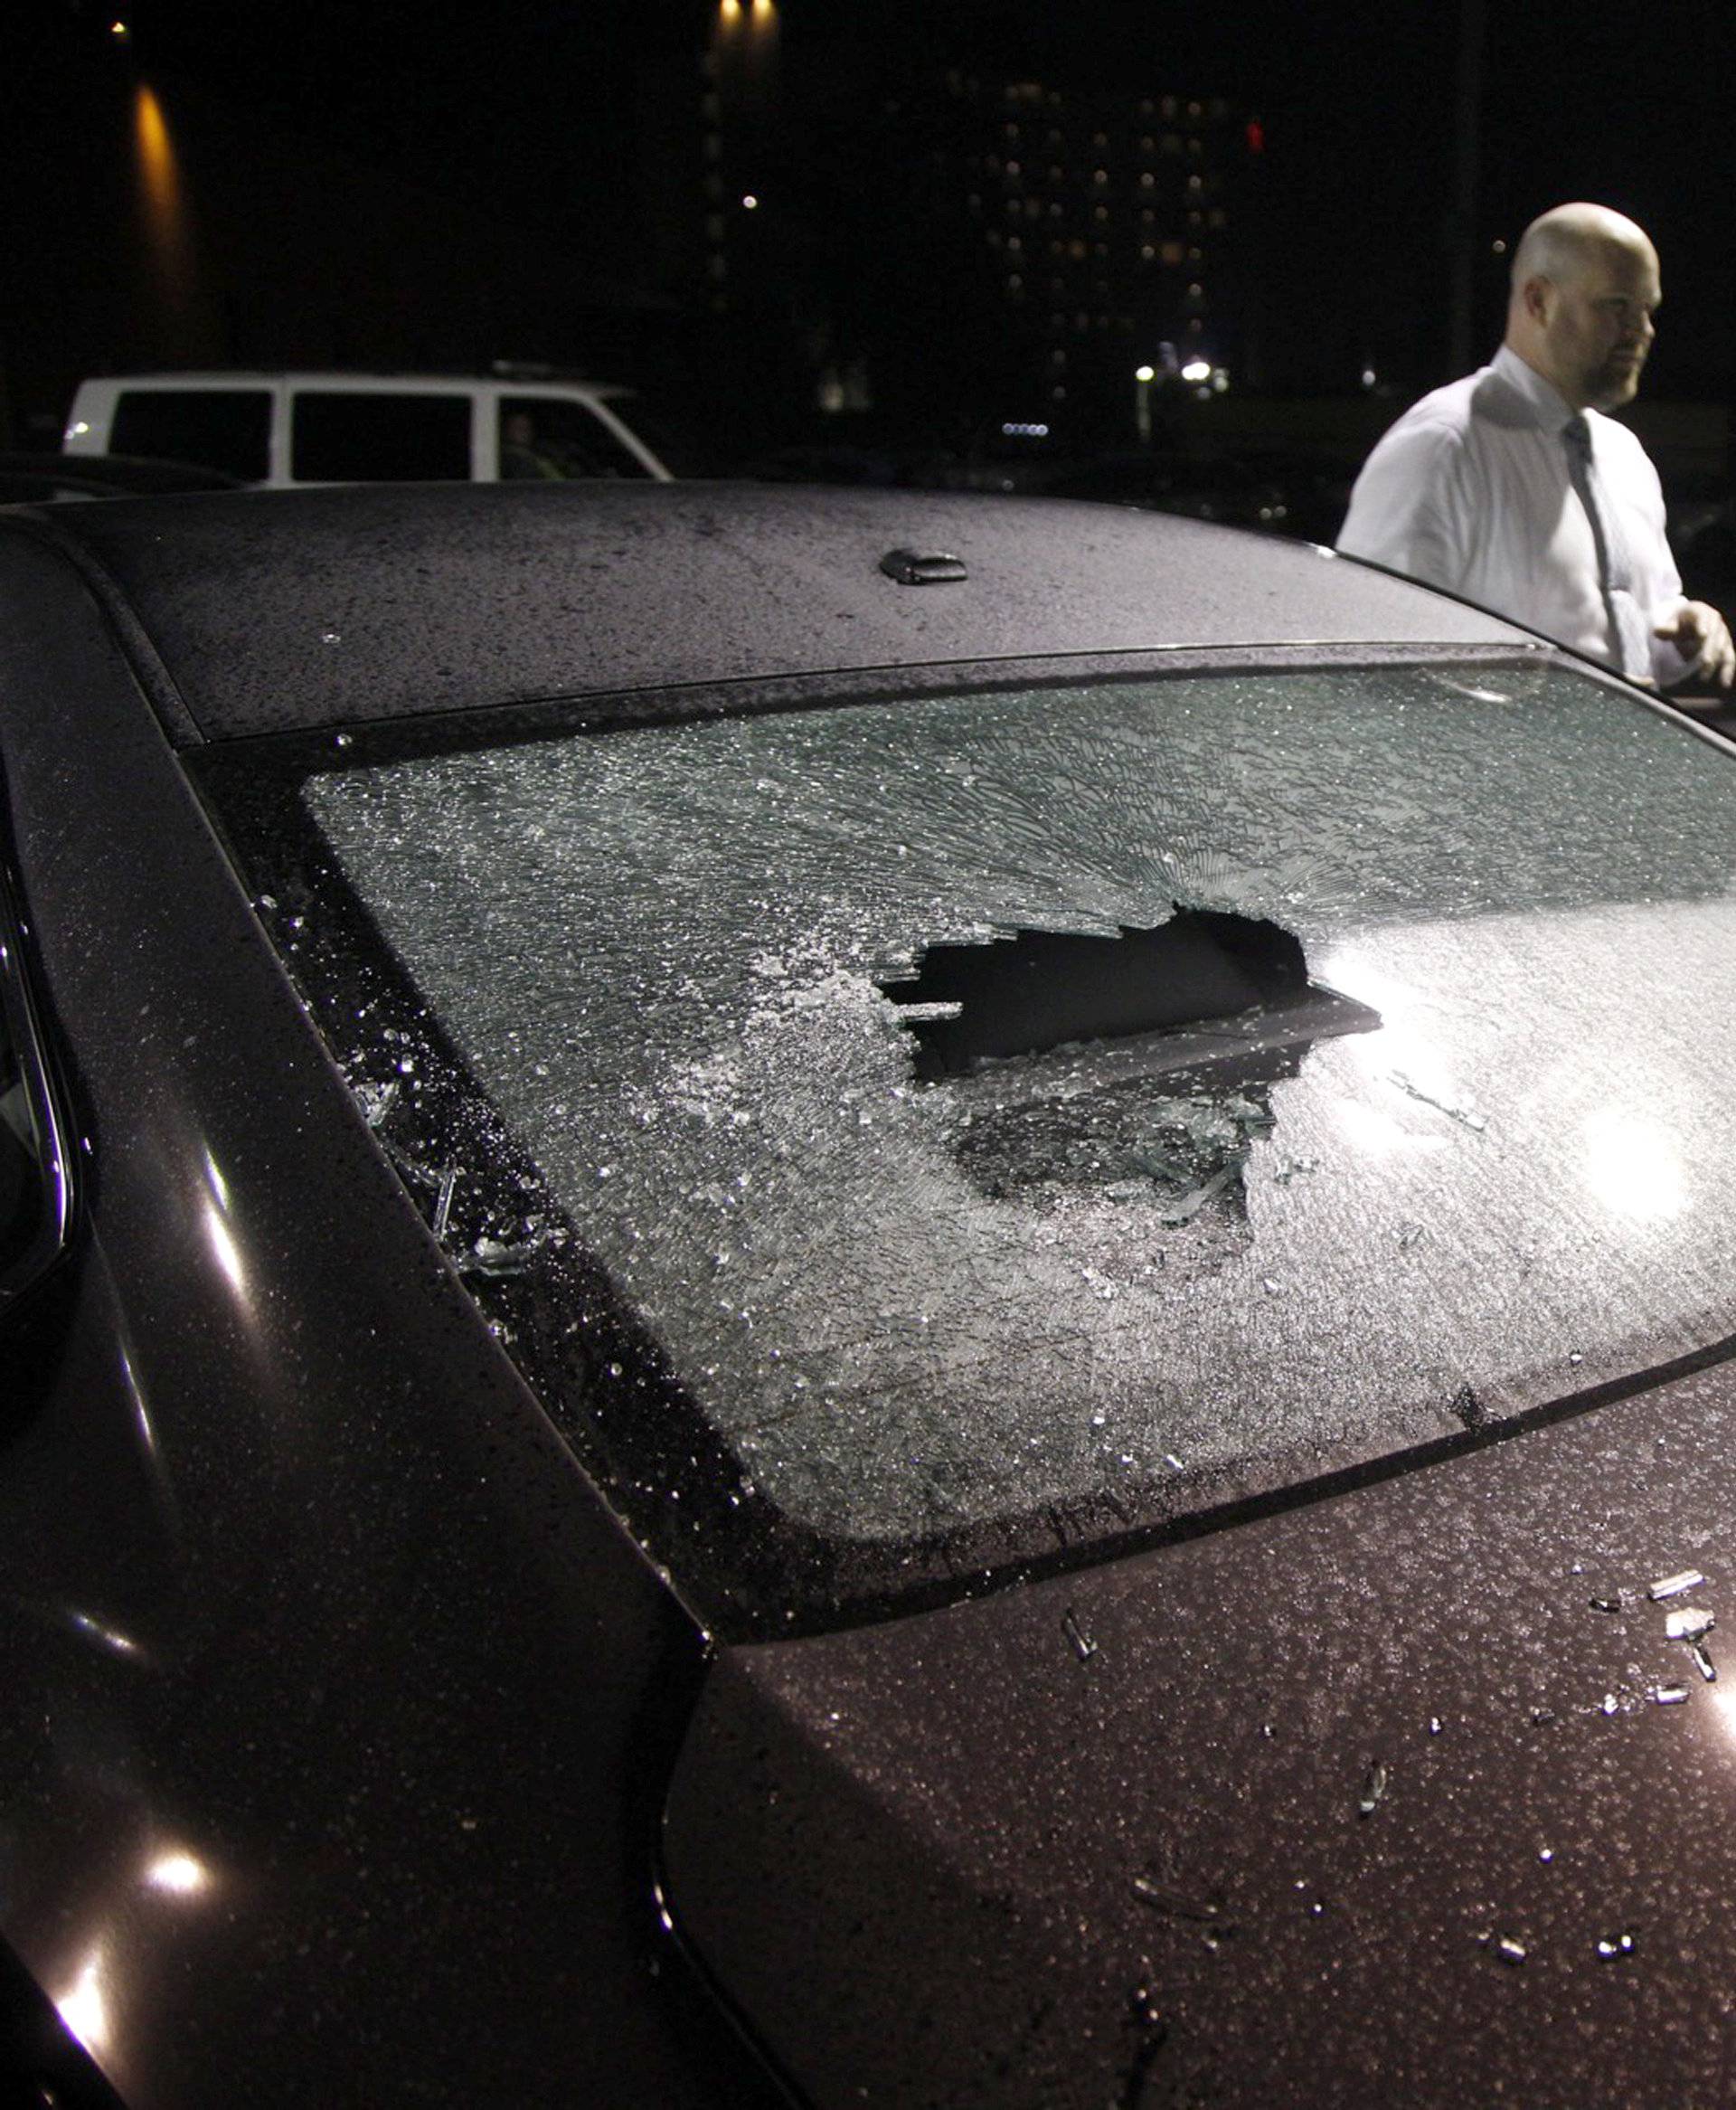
[{"x1": 63, "y1": 369, "x2": 671, "y2": 486}]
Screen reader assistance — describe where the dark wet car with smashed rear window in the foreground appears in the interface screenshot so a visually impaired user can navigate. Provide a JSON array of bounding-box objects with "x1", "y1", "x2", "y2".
[{"x1": 0, "y1": 481, "x2": 1736, "y2": 2110}]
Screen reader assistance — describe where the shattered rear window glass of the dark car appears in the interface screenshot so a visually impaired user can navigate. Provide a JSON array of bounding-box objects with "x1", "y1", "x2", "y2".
[{"x1": 223, "y1": 663, "x2": 1736, "y2": 1620}]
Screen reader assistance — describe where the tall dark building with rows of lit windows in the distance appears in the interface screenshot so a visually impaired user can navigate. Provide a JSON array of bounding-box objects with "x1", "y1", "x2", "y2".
[{"x1": 690, "y1": 0, "x2": 1263, "y2": 439}]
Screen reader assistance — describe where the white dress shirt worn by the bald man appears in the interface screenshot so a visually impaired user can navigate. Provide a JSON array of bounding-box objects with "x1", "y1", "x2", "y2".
[{"x1": 1337, "y1": 346, "x2": 1687, "y2": 684}]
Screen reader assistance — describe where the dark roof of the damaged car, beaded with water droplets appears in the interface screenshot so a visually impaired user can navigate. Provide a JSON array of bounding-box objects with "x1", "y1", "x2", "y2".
[{"x1": 0, "y1": 483, "x2": 1529, "y2": 741}]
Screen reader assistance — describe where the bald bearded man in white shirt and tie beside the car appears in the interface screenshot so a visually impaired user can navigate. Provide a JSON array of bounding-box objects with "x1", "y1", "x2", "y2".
[{"x1": 1337, "y1": 204, "x2": 1736, "y2": 688}]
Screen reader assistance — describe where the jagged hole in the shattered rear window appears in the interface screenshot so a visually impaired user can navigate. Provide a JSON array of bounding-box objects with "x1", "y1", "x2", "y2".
[{"x1": 880, "y1": 910, "x2": 1380, "y2": 1228}]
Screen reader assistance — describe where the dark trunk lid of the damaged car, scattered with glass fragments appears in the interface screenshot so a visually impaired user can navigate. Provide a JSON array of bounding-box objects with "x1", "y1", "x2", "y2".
[{"x1": 665, "y1": 1367, "x2": 1736, "y2": 2110}]
